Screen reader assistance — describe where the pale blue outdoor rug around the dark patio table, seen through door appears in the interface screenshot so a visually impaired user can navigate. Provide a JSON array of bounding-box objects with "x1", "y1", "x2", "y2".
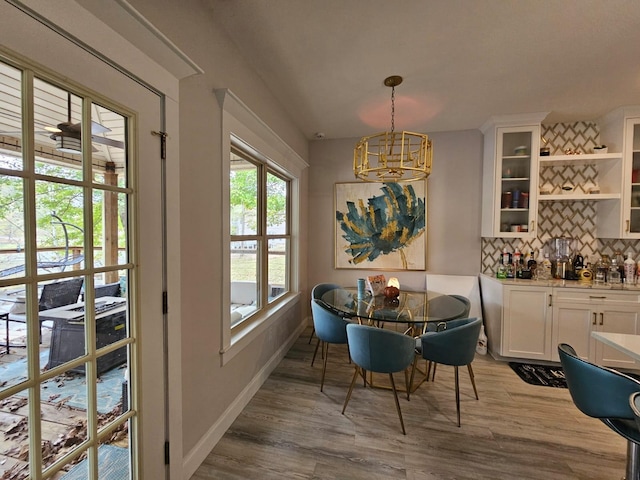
[{"x1": 0, "y1": 350, "x2": 125, "y2": 413}]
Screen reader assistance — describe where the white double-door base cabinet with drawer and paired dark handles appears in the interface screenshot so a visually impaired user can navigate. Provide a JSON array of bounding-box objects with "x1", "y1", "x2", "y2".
[{"x1": 552, "y1": 288, "x2": 640, "y2": 368}]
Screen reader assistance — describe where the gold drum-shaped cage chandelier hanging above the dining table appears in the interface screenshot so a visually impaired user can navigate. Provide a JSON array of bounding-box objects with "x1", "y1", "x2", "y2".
[{"x1": 353, "y1": 75, "x2": 433, "y2": 182}]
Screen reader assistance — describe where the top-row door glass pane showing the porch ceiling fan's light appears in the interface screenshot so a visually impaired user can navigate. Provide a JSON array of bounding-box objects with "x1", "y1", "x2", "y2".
[{"x1": 33, "y1": 78, "x2": 82, "y2": 180}]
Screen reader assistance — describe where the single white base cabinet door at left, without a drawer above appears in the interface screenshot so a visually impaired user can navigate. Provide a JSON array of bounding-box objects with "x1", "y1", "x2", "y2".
[{"x1": 500, "y1": 286, "x2": 552, "y2": 360}]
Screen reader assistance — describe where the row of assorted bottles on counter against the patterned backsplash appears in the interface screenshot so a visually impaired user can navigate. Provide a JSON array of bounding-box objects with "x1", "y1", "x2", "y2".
[{"x1": 496, "y1": 247, "x2": 640, "y2": 286}]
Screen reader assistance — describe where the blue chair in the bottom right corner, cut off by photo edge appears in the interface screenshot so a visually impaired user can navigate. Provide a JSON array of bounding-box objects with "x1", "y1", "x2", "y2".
[{"x1": 558, "y1": 343, "x2": 640, "y2": 480}]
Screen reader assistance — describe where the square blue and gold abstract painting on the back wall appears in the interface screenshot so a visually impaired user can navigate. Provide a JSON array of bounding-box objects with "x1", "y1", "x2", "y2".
[{"x1": 335, "y1": 181, "x2": 427, "y2": 270}]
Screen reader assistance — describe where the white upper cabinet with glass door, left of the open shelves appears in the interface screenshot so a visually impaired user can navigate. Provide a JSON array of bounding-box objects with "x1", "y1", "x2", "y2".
[{"x1": 482, "y1": 114, "x2": 546, "y2": 238}]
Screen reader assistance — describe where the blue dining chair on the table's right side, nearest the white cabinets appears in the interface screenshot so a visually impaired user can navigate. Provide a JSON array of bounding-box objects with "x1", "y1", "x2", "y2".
[{"x1": 411, "y1": 318, "x2": 482, "y2": 426}]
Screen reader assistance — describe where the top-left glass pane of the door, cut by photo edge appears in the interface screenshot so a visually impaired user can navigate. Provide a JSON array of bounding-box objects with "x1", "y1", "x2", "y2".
[{"x1": 0, "y1": 62, "x2": 24, "y2": 170}]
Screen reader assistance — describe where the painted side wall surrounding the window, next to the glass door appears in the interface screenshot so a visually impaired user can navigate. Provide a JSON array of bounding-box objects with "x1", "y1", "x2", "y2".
[{"x1": 123, "y1": 0, "x2": 308, "y2": 472}]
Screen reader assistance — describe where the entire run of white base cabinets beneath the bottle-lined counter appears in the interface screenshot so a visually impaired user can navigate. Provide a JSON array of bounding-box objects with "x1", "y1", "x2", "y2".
[{"x1": 480, "y1": 275, "x2": 640, "y2": 369}]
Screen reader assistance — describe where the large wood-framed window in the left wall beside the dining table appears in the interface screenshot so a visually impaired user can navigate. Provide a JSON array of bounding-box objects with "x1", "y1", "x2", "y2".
[{"x1": 229, "y1": 141, "x2": 291, "y2": 329}]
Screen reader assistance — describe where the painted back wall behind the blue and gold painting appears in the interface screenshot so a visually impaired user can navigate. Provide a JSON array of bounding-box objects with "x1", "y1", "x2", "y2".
[{"x1": 308, "y1": 130, "x2": 483, "y2": 288}]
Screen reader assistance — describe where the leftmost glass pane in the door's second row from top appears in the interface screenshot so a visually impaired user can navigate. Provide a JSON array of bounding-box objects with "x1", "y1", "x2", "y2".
[{"x1": 0, "y1": 175, "x2": 25, "y2": 278}]
